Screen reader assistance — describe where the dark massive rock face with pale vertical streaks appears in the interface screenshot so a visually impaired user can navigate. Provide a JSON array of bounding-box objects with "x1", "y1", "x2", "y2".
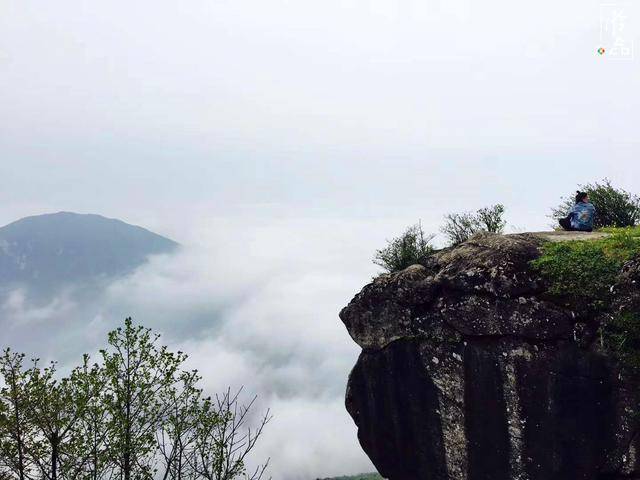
[{"x1": 340, "y1": 234, "x2": 640, "y2": 480}]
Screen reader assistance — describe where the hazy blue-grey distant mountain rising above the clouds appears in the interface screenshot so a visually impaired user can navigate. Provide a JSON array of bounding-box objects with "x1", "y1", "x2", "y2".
[{"x1": 0, "y1": 212, "x2": 178, "y2": 291}]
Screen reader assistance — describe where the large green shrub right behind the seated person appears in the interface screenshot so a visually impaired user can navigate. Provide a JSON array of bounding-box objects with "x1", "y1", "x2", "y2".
[{"x1": 552, "y1": 178, "x2": 640, "y2": 228}]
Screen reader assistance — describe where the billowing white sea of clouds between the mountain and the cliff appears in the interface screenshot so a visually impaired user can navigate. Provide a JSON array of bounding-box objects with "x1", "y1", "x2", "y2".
[{"x1": 0, "y1": 218, "x2": 420, "y2": 480}]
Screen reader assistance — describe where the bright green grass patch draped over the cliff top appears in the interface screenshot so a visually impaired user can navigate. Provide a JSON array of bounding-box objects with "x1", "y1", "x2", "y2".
[{"x1": 532, "y1": 227, "x2": 640, "y2": 310}]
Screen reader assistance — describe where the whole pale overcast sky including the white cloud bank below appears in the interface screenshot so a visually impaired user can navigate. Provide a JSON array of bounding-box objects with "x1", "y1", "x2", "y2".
[{"x1": 0, "y1": 0, "x2": 640, "y2": 480}]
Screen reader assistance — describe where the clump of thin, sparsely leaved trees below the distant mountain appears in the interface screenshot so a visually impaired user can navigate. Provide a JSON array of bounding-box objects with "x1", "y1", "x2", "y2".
[{"x1": 0, "y1": 319, "x2": 271, "y2": 480}]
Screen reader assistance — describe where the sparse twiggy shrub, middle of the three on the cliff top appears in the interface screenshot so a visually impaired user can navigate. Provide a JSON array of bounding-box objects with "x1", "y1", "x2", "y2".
[{"x1": 441, "y1": 204, "x2": 506, "y2": 245}]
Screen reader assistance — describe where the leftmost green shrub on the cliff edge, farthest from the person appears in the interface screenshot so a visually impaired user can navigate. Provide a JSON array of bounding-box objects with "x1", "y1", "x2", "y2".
[{"x1": 373, "y1": 222, "x2": 435, "y2": 272}]
